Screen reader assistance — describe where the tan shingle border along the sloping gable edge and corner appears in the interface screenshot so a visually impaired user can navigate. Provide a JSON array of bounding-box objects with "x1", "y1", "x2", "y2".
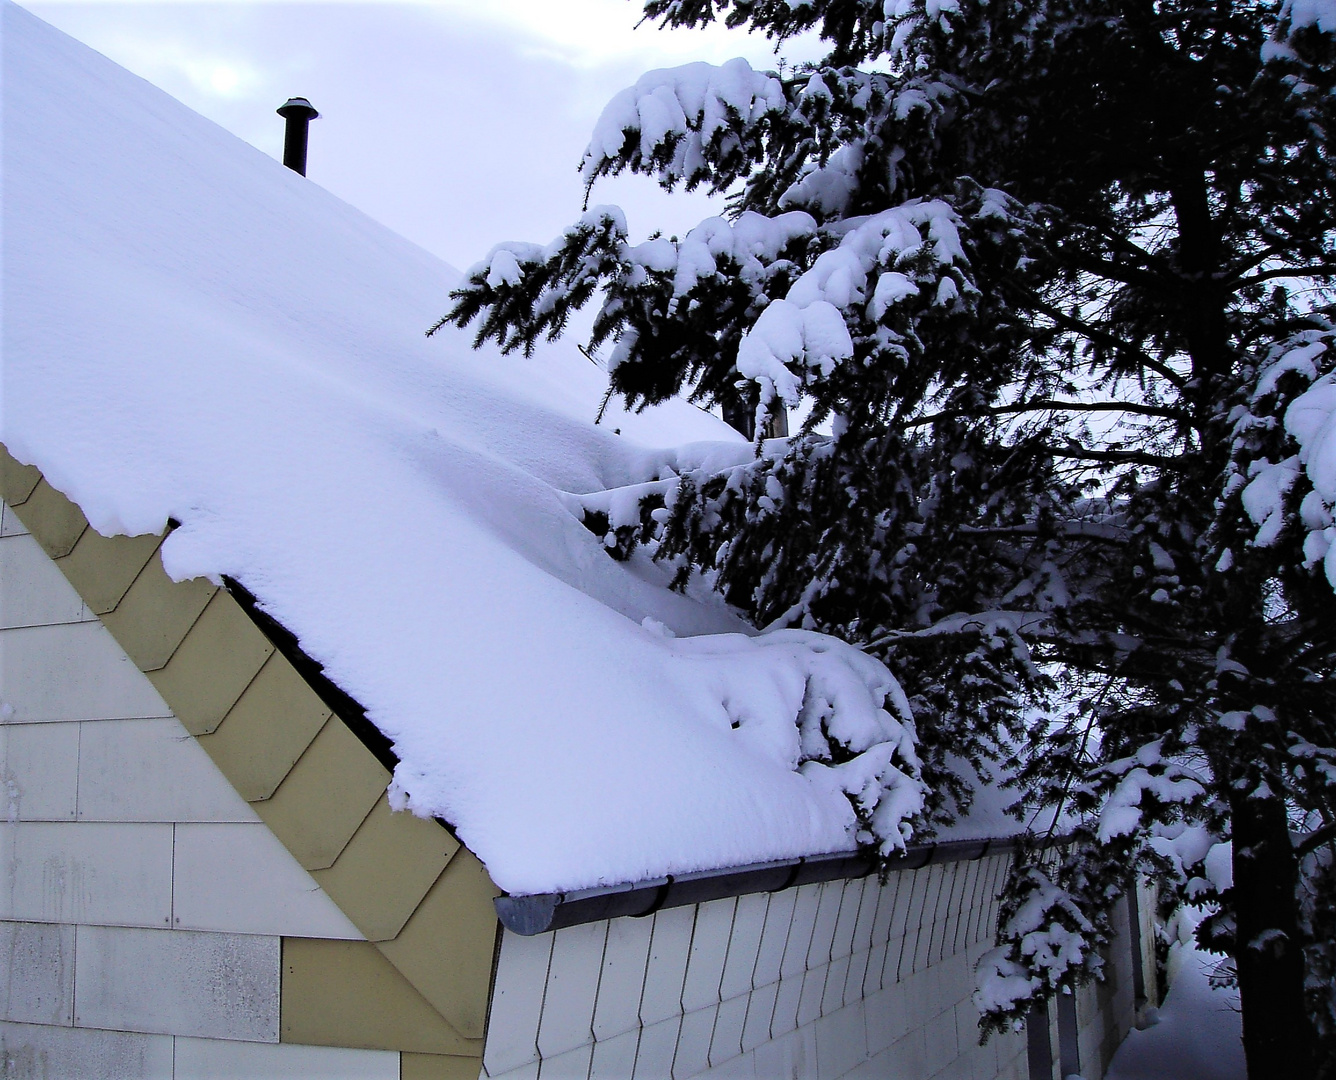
[{"x1": 0, "y1": 446, "x2": 497, "y2": 1077}]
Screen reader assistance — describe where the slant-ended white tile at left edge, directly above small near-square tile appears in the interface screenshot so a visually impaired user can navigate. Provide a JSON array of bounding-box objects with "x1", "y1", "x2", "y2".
[{"x1": 0, "y1": 623, "x2": 170, "y2": 723}]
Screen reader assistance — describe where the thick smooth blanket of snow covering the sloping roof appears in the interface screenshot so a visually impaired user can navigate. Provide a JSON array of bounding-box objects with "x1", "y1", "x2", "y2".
[{"x1": 0, "y1": 0, "x2": 919, "y2": 893}]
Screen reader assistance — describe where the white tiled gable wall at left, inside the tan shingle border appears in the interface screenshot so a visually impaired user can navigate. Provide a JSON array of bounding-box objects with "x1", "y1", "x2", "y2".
[{"x1": 0, "y1": 504, "x2": 401, "y2": 1080}]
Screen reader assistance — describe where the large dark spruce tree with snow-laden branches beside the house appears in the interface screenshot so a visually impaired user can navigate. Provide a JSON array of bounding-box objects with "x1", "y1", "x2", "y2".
[{"x1": 442, "y1": 0, "x2": 1336, "y2": 1080}]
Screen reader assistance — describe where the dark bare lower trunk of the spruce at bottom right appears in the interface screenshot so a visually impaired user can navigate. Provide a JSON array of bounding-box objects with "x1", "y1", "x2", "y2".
[{"x1": 1230, "y1": 774, "x2": 1316, "y2": 1080}]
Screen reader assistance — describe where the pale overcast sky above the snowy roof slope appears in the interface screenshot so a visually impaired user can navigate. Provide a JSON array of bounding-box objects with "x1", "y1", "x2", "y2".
[{"x1": 24, "y1": 0, "x2": 810, "y2": 270}]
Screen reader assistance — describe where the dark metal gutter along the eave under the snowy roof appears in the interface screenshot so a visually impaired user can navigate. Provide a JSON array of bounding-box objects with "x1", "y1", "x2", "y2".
[{"x1": 493, "y1": 837, "x2": 1019, "y2": 937}]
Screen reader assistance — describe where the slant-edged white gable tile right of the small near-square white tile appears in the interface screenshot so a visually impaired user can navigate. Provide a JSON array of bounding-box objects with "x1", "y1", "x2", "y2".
[{"x1": 79, "y1": 716, "x2": 259, "y2": 821}]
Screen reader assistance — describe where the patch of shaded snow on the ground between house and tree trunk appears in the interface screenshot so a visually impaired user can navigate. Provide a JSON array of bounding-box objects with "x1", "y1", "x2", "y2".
[{"x1": 1105, "y1": 925, "x2": 1248, "y2": 1080}]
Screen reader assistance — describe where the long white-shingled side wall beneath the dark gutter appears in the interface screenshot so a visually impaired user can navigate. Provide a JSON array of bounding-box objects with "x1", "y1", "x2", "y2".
[{"x1": 484, "y1": 855, "x2": 1029, "y2": 1080}]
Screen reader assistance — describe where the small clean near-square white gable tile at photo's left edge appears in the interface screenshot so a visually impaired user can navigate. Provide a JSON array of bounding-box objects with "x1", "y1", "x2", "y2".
[{"x1": 0, "y1": 723, "x2": 79, "y2": 821}]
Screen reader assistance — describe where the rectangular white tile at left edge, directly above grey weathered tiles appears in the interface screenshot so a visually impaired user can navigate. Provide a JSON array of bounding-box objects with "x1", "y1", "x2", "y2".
[{"x1": 0, "y1": 822, "x2": 171, "y2": 926}]
